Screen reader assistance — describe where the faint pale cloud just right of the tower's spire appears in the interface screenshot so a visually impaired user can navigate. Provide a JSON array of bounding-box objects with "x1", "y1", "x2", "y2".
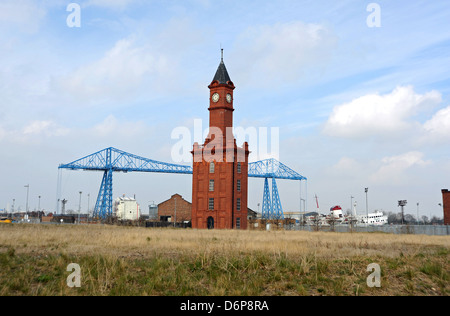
[{"x1": 233, "y1": 21, "x2": 337, "y2": 86}]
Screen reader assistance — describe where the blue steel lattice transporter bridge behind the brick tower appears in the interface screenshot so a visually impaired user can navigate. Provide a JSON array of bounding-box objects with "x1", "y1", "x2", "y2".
[{"x1": 59, "y1": 147, "x2": 307, "y2": 219}]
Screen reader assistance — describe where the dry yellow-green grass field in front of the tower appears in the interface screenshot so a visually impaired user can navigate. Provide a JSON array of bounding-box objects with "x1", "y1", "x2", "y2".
[{"x1": 0, "y1": 224, "x2": 450, "y2": 296}]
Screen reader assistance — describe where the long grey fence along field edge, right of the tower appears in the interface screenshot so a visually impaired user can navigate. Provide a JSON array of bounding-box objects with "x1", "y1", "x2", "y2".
[{"x1": 285, "y1": 225, "x2": 450, "y2": 236}]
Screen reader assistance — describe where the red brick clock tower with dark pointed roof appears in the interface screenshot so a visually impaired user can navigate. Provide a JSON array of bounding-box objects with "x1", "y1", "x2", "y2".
[{"x1": 192, "y1": 50, "x2": 249, "y2": 229}]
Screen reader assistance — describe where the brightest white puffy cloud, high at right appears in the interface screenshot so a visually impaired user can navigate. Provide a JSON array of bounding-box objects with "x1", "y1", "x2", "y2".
[{"x1": 323, "y1": 86, "x2": 441, "y2": 138}]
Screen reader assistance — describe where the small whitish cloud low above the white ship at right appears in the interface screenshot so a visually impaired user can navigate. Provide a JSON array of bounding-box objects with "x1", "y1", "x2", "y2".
[{"x1": 370, "y1": 151, "x2": 431, "y2": 184}]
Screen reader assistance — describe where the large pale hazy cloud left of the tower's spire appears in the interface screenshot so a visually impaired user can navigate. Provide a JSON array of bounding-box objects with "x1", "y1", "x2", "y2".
[{"x1": 55, "y1": 19, "x2": 203, "y2": 105}]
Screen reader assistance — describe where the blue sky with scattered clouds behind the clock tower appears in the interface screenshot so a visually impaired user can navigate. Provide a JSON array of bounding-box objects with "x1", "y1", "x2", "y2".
[{"x1": 0, "y1": 0, "x2": 450, "y2": 217}]
